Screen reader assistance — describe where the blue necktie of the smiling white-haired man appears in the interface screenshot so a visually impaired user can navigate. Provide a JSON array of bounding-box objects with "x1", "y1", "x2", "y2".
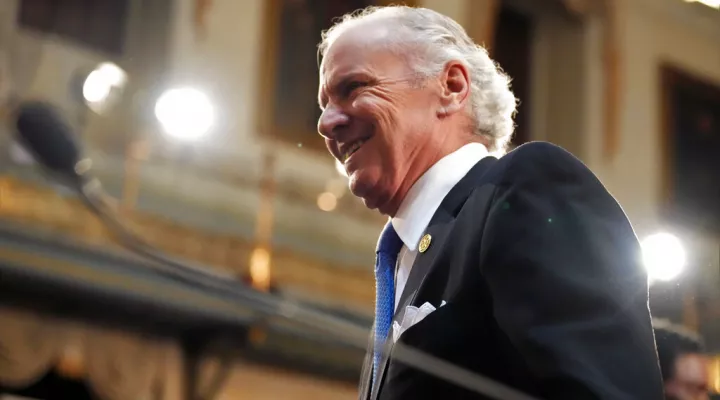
[{"x1": 373, "y1": 222, "x2": 403, "y2": 385}]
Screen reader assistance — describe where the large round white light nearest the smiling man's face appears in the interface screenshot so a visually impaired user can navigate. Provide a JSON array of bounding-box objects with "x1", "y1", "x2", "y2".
[{"x1": 155, "y1": 88, "x2": 215, "y2": 140}]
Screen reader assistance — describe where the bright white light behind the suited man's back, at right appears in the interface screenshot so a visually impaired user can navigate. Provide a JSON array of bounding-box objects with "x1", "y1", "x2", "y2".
[{"x1": 641, "y1": 233, "x2": 686, "y2": 282}]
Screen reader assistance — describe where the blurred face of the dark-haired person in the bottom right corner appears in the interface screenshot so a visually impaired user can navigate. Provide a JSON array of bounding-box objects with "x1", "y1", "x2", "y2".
[{"x1": 665, "y1": 354, "x2": 709, "y2": 400}]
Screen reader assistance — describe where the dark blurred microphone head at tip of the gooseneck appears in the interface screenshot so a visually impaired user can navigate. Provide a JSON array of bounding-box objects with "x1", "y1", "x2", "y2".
[{"x1": 15, "y1": 102, "x2": 80, "y2": 177}]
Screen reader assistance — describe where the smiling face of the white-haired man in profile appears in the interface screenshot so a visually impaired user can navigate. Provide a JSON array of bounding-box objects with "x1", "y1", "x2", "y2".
[{"x1": 318, "y1": 22, "x2": 441, "y2": 215}]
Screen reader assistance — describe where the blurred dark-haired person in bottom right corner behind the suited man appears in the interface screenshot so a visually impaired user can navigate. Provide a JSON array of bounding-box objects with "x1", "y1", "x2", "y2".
[{"x1": 655, "y1": 321, "x2": 710, "y2": 400}]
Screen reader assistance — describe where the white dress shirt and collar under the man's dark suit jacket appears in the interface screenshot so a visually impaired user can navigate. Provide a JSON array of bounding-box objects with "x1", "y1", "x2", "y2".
[{"x1": 392, "y1": 143, "x2": 488, "y2": 308}]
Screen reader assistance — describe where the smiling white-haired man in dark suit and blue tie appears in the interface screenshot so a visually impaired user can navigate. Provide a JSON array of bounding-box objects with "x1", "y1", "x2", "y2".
[{"x1": 318, "y1": 7, "x2": 663, "y2": 400}]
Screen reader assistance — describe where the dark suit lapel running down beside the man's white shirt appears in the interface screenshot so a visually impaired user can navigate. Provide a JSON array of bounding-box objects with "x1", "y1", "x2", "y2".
[{"x1": 370, "y1": 157, "x2": 497, "y2": 400}]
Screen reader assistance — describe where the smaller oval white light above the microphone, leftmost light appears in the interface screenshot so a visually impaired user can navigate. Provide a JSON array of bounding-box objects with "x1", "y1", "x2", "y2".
[{"x1": 83, "y1": 63, "x2": 127, "y2": 112}]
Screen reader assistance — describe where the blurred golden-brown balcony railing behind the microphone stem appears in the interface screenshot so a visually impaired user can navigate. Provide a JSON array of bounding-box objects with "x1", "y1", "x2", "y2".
[{"x1": 0, "y1": 177, "x2": 374, "y2": 311}]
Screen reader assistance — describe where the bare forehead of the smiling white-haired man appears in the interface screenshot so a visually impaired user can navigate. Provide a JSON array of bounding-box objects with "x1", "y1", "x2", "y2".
[{"x1": 320, "y1": 20, "x2": 406, "y2": 86}]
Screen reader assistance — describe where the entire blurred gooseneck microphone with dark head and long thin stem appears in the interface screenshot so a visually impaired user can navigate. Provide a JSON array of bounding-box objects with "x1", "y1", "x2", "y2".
[{"x1": 9, "y1": 102, "x2": 534, "y2": 400}]
